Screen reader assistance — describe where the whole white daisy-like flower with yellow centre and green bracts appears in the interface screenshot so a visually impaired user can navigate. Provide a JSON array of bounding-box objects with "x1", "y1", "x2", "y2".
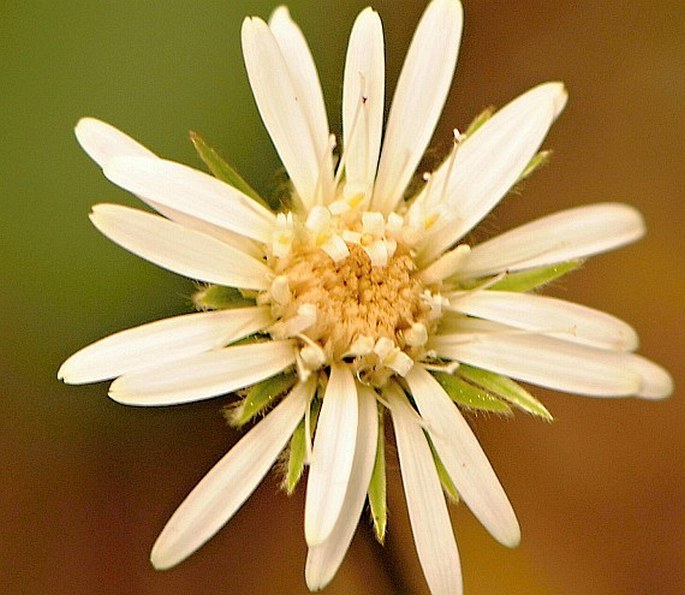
[{"x1": 59, "y1": 0, "x2": 671, "y2": 593}]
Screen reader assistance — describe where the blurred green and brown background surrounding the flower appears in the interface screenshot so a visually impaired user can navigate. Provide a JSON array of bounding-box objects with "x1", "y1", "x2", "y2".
[{"x1": 0, "y1": 0, "x2": 685, "y2": 595}]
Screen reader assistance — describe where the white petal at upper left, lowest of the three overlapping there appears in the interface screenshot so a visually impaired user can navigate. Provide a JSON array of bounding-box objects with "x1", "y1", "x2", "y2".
[{"x1": 90, "y1": 204, "x2": 271, "y2": 289}]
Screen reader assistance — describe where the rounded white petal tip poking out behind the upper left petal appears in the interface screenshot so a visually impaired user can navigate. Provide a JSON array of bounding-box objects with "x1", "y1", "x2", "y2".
[{"x1": 74, "y1": 118, "x2": 156, "y2": 167}]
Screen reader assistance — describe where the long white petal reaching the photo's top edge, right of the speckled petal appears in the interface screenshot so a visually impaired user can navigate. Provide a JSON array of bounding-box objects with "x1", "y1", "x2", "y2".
[{"x1": 372, "y1": 0, "x2": 463, "y2": 214}]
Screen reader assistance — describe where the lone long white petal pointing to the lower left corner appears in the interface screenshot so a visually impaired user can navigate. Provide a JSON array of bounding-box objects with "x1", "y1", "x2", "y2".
[{"x1": 150, "y1": 381, "x2": 314, "y2": 570}]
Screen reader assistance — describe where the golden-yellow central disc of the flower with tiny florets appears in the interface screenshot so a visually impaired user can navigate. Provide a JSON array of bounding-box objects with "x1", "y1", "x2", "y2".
[{"x1": 260, "y1": 228, "x2": 435, "y2": 386}]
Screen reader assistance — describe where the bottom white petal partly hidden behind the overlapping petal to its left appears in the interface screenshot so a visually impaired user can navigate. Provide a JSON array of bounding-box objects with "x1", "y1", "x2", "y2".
[{"x1": 304, "y1": 387, "x2": 378, "y2": 591}]
